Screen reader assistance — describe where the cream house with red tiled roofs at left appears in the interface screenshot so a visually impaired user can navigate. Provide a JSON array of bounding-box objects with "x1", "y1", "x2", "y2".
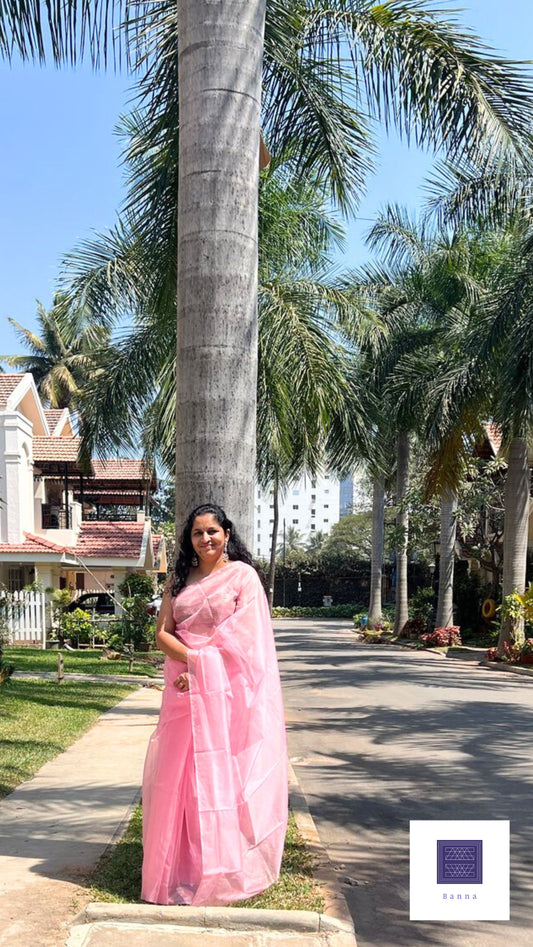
[{"x1": 0, "y1": 373, "x2": 166, "y2": 592}]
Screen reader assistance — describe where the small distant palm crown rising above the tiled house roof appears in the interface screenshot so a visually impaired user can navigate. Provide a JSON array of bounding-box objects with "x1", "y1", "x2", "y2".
[{"x1": 0, "y1": 295, "x2": 109, "y2": 408}]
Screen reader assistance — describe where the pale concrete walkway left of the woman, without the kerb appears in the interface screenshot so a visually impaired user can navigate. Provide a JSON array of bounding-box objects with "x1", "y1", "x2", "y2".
[{"x1": 0, "y1": 688, "x2": 161, "y2": 947}]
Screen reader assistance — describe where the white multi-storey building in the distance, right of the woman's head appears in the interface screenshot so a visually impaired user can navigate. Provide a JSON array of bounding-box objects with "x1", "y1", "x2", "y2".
[{"x1": 253, "y1": 473, "x2": 340, "y2": 559}]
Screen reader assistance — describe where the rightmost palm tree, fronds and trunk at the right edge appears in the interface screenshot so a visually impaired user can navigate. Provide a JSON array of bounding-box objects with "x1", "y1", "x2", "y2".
[{"x1": 424, "y1": 159, "x2": 533, "y2": 653}]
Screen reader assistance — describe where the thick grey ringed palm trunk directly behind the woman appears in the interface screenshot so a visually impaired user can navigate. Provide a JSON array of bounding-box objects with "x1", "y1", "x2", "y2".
[{"x1": 176, "y1": 0, "x2": 266, "y2": 546}]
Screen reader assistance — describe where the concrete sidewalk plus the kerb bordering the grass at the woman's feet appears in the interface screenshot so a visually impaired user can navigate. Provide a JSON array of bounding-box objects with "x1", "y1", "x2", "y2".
[{"x1": 0, "y1": 682, "x2": 355, "y2": 947}]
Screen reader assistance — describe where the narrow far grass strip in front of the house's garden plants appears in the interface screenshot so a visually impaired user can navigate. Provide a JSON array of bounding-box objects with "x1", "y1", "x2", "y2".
[{"x1": 4, "y1": 647, "x2": 164, "y2": 677}]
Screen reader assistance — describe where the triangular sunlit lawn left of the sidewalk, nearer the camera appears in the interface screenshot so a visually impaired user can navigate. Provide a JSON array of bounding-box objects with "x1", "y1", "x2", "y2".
[{"x1": 0, "y1": 678, "x2": 133, "y2": 798}]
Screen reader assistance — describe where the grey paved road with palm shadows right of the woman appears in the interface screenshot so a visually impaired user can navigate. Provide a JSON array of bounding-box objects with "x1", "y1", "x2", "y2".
[{"x1": 275, "y1": 621, "x2": 533, "y2": 947}]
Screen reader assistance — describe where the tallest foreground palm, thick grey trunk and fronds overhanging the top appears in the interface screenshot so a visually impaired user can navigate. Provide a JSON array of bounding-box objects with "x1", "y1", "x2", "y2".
[{"x1": 4, "y1": 0, "x2": 531, "y2": 529}]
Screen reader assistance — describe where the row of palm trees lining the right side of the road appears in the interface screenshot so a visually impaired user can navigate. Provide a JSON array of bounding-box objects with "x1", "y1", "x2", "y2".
[{"x1": 354, "y1": 197, "x2": 533, "y2": 649}]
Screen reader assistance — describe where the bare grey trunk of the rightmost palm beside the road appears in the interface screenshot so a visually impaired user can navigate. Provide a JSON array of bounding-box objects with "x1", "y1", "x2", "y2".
[{"x1": 498, "y1": 437, "x2": 529, "y2": 651}]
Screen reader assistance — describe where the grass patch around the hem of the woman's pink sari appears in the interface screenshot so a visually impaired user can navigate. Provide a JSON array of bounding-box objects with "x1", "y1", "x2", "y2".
[{"x1": 90, "y1": 806, "x2": 324, "y2": 911}]
